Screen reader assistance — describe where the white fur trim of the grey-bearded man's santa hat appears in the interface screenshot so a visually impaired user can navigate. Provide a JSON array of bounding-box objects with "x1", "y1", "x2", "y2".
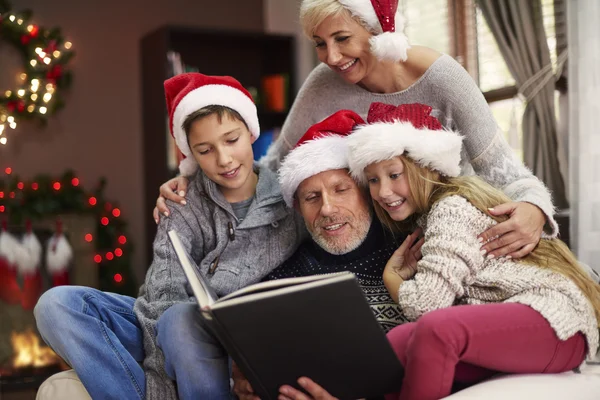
[{"x1": 279, "y1": 135, "x2": 348, "y2": 207}]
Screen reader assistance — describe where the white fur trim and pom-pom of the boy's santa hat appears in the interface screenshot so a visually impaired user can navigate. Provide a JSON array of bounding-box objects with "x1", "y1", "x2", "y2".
[{"x1": 172, "y1": 84, "x2": 260, "y2": 175}]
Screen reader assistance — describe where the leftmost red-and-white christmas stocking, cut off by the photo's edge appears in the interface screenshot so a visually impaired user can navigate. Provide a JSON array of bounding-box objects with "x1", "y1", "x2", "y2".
[{"x1": 0, "y1": 222, "x2": 21, "y2": 304}]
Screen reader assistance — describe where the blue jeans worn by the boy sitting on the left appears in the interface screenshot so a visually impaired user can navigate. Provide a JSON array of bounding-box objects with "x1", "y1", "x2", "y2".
[{"x1": 34, "y1": 286, "x2": 230, "y2": 400}]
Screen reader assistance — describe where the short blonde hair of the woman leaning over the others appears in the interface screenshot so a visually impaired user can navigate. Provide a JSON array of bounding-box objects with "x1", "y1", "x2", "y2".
[{"x1": 300, "y1": 0, "x2": 371, "y2": 40}]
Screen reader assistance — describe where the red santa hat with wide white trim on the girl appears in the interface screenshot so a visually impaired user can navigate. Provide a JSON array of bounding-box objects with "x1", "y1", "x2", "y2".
[{"x1": 348, "y1": 103, "x2": 462, "y2": 184}]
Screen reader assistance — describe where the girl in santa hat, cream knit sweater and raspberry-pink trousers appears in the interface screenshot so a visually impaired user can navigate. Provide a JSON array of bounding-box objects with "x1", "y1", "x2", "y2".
[{"x1": 348, "y1": 104, "x2": 600, "y2": 400}]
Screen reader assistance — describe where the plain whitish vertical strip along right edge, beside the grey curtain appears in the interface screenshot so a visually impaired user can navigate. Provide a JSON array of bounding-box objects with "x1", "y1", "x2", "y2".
[{"x1": 567, "y1": 0, "x2": 600, "y2": 272}]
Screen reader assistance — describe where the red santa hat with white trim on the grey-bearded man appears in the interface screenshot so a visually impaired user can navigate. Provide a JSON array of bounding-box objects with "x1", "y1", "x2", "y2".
[{"x1": 279, "y1": 110, "x2": 364, "y2": 207}]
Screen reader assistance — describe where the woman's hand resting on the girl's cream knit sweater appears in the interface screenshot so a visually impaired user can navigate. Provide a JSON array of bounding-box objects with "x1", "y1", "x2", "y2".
[{"x1": 479, "y1": 202, "x2": 546, "y2": 258}]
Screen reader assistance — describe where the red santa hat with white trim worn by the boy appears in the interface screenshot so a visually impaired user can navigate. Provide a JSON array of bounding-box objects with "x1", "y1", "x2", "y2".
[{"x1": 165, "y1": 72, "x2": 260, "y2": 175}]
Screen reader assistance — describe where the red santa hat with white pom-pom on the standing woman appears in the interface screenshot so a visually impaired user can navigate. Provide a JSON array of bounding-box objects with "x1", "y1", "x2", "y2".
[{"x1": 339, "y1": 0, "x2": 410, "y2": 61}]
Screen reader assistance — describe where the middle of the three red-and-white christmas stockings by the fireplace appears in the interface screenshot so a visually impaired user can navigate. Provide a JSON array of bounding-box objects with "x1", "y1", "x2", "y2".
[{"x1": 17, "y1": 221, "x2": 42, "y2": 310}]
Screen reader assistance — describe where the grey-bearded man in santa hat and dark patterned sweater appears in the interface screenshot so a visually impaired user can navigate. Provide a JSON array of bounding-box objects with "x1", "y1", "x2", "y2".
[{"x1": 266, "y1": 110, "x2": 410, "y2": 332}]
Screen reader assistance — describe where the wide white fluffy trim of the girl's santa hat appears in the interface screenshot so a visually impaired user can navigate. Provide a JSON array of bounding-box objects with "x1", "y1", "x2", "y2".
[{"x1": 348, "y1": 121, "x2": 462, "y2": 184}]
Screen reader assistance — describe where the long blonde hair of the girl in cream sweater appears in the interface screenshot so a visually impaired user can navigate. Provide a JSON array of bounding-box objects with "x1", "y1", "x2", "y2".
[{"x1": 373, "y1": 156, "x2": 600, "y2": 326}]
